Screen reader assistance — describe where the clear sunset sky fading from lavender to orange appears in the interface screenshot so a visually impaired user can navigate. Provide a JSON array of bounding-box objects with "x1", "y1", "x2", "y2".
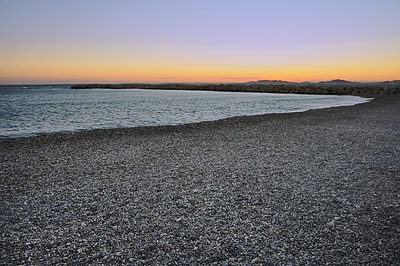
[{"x1": 0, "y1": 0, "x2": 400, "y2": 84}]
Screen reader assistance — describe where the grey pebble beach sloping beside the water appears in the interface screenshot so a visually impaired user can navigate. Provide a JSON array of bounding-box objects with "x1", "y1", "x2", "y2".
[{"x1": 0, "y1": 95, "x2": 400, "y2": 265}]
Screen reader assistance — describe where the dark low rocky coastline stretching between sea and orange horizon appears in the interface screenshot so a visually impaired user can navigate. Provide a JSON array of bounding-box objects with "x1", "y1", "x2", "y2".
[{"x1": 72, "y1": 79, "x2": 400, "y2": 97}]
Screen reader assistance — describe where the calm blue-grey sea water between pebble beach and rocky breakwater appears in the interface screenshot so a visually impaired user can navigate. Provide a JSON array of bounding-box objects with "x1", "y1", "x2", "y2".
[{"x1": 0, "y1": 85, "x2": 367, "y2": 138}]
